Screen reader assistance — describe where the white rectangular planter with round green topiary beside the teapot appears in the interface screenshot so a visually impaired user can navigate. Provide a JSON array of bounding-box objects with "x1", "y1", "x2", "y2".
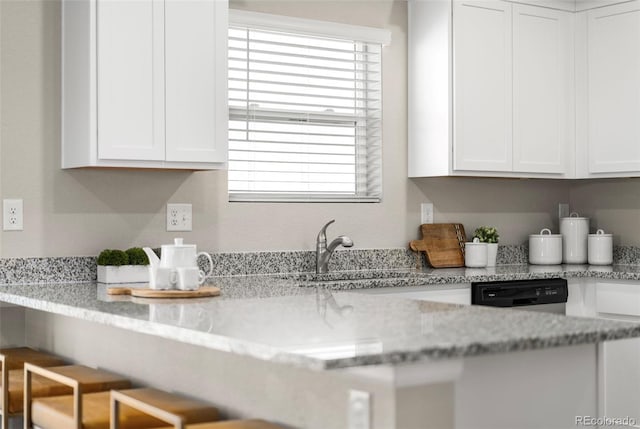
[{"x1": 98, "y1": 247, "x2": 149, "y2": 283}]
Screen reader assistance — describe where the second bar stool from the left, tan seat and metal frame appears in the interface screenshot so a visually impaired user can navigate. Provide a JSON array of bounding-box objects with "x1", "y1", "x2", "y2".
[{"x1": 24, "y1": 363, "x2": 131, "y2": 429}]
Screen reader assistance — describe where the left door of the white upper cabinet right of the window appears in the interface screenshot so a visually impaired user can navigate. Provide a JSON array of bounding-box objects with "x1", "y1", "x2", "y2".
[{"x1": 453, "y1": 1, "x2": 512, "y2": 171}]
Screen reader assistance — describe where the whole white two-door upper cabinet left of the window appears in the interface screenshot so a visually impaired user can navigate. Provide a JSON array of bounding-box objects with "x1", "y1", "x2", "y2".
[{"x1": 62, "y1": 0, "x2": 228, "y2": 169}]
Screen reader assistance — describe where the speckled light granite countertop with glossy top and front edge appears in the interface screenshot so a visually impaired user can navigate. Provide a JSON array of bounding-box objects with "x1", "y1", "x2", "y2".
[{"x1": 0, "y1": 265, "x2": 640, "y2": 370}]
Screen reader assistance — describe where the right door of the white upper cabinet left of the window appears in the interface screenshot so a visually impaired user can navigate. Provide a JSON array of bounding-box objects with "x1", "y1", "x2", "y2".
[{"x1": 165, "y1": 0, "x2": 228, "y2": 162}]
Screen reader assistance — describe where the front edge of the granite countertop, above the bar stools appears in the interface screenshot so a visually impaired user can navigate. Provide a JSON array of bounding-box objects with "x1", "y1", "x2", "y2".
[{"x1": 5, "y1": 284, "x2": 640, "y2": 371}]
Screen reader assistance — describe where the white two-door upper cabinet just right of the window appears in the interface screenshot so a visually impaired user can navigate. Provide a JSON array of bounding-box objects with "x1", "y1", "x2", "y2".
[{"x1": 409, "y1": 0, "x2": 574, "y2": 178}]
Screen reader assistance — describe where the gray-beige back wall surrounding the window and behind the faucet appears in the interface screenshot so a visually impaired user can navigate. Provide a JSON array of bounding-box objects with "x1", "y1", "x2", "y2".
[{"x1": 0, "y1": 0, "x2": 576, "y2": 257}]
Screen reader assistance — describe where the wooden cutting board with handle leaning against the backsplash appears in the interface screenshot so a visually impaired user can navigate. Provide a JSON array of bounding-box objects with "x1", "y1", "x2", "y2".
[{"x1": 409, "y1": 223, "x2": 466, "y2": 268}]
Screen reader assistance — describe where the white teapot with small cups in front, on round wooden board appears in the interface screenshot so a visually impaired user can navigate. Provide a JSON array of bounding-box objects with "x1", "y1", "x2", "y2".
[{"x1": 142, "y1": 238, "x2": 213, "y2": 290}]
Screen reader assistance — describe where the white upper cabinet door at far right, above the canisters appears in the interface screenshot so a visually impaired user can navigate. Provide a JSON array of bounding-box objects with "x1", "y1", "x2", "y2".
[{"x1": 587, "y1": 1, "x2": 640, "y2": 173}]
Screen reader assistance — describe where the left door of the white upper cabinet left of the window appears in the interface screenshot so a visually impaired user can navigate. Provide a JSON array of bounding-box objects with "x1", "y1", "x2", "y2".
[{"x1": 96, "y1": 0, "x2": 164, "y2": 160}]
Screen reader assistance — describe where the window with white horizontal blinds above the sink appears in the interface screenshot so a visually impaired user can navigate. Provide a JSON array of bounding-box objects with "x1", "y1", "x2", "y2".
[{"x1": 229, "y1": 10, "x2": 389, "y2": 202}]
